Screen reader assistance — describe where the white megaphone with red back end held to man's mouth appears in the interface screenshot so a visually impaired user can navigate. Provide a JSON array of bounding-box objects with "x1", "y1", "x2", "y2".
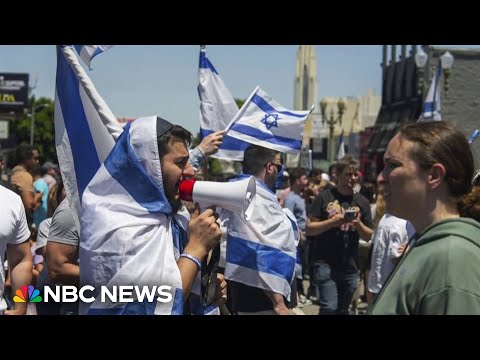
[{"x1": 179, "y1": 176, "x2": 257, "y2": 221}]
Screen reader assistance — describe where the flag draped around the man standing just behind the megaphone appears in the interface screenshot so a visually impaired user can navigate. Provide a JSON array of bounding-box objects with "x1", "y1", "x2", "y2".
[{"x1": 220, "y1": 175, "x2": 296, "y2": 300}]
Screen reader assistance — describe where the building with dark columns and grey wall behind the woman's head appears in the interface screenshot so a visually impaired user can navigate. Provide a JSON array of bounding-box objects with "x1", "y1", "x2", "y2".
[{"x1": 360, "y1": 45, "x2": 480, "y2": 181}]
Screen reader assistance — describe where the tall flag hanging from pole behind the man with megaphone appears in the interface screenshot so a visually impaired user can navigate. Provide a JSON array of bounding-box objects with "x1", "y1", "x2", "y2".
[{"x1": 54, "y1": 46, "x2": 123, "y2": 225}]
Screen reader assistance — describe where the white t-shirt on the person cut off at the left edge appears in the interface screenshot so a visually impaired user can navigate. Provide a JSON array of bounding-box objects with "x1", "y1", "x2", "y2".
[{"x1": 0, "y1": 185, "x2": 30, "y2": 299}]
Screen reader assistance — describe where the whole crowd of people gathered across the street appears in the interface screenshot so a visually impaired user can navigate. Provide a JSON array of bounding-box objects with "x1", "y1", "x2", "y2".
[{"x1": 0, "y1": 117, "x2": 480, "y2": 315}]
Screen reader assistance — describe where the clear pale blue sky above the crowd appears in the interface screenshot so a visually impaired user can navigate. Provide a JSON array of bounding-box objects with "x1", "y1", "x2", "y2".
[{"x1": 0, "y1": 45, "x2": 480, "y2": 133}]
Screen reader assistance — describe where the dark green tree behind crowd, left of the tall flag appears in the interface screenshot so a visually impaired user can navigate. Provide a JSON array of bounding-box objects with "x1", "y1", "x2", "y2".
[{"x1": 11, "y1": 97, "x2": 58, "y2": 163}]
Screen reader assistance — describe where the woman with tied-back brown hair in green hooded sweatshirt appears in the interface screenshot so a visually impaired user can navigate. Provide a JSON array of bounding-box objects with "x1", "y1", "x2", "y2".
[{"x1": 369, "y1": 122, "x2": 480, "y2": 315}]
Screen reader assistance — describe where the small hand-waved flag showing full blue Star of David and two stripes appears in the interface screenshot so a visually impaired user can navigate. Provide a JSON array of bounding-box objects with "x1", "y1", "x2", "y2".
[{"x1": 227, "y1": 86, "x2": 314, "y2": 155}]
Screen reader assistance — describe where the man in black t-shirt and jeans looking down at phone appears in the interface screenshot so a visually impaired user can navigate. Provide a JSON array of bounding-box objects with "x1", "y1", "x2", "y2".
[{"x1": 307, "y1": 155, "x2": 373, "y2": 315}]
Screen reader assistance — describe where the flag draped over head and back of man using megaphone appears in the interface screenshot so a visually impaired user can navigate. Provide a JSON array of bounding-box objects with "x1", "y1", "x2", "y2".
[{"x1": 80, "y1": 116, "x2": 189, "y2": 315}]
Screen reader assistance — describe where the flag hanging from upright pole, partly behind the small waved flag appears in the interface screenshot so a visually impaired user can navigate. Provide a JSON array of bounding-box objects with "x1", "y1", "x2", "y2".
[{"x1": 198, "y1": 48, "x2": 250, "y2": 161}]
